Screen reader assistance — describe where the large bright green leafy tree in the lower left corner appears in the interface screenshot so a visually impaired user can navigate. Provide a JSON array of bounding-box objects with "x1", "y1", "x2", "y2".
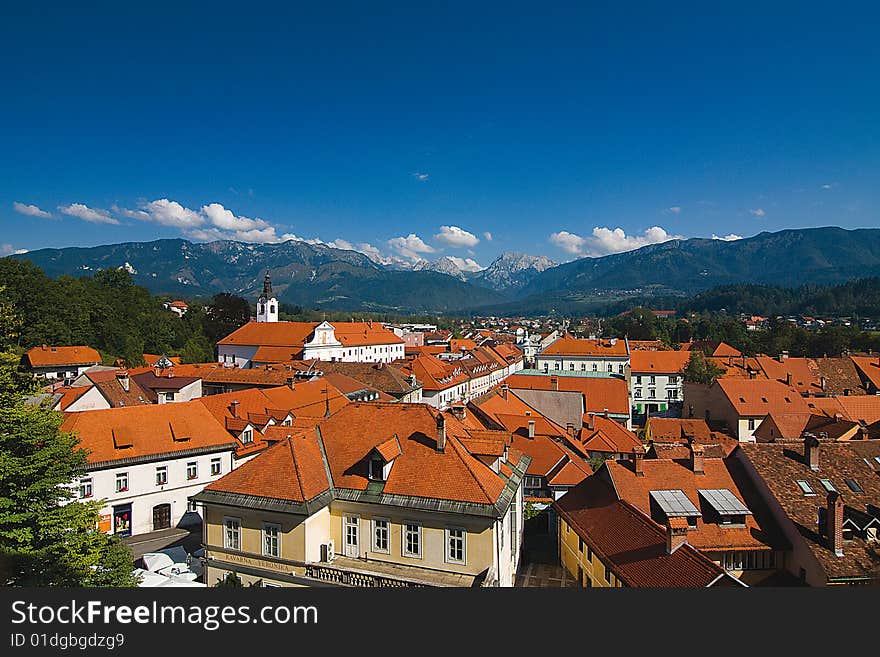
[{"x1": 0, "y1": 289, "x2": 137, "y2": 586}]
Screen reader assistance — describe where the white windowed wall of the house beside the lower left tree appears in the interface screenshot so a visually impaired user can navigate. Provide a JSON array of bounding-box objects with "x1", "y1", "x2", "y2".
[{"x1": 77, "y1": 450, "x2": 232, "y2": 535}]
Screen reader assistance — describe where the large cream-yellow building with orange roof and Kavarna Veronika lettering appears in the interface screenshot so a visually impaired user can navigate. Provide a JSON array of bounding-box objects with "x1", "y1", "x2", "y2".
[{"x1": 194, "y1": 403, "x2": 529, "y2": 587}]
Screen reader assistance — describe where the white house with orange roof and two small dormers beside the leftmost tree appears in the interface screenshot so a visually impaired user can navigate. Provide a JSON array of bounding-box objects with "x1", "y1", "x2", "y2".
[{"x1": 61, "y1": 402, "x2": 237, "y2": 536}]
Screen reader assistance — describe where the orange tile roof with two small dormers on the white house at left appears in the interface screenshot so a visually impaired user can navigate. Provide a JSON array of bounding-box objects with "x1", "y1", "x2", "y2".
[{"x1": 61, "y1": 401, "x2": 235, "y2": 464}]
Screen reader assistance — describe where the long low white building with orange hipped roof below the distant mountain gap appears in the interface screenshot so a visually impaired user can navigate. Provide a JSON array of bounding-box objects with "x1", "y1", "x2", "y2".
[{"x1": 535, "y1": 335, "x2": 630, "y2": 376}]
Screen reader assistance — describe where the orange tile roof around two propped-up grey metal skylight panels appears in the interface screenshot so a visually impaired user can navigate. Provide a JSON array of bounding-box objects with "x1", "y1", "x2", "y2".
[{"x1": 605, "y1": 458, "x2": 786, "y2": 551}]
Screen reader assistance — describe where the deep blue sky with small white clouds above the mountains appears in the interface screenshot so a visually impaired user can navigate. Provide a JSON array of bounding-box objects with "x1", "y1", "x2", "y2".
[{"x1": 0, "y1": 2, "x2": 880, "y2": 265}]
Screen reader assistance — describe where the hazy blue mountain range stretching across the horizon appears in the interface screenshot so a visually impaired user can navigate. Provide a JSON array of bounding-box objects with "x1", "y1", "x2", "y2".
[{"x1": 10, "y1": 227, "x2": 880, "y2": 314}]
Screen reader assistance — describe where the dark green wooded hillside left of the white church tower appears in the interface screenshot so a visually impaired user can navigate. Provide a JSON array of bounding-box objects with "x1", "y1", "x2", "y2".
[{"x1": 0, "y1": 258, "x2": 250, "y2": 366}]
